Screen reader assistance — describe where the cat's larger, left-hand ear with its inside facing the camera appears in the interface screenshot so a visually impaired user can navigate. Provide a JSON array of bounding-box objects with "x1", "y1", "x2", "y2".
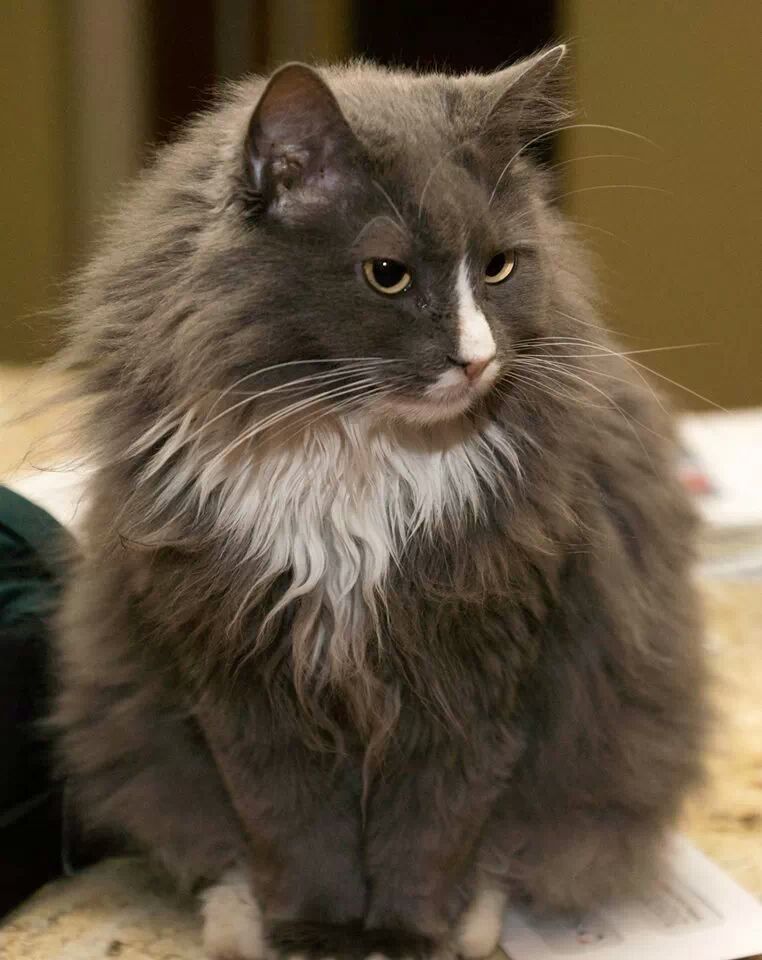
[{"x1": 245, "y1": 63, "x2": 360, "y2": 216}]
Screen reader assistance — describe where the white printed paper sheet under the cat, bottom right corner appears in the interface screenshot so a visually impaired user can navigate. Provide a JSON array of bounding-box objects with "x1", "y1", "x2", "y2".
[{"x1": 500, "y1": 837, "x2": 762, "y2": 960}]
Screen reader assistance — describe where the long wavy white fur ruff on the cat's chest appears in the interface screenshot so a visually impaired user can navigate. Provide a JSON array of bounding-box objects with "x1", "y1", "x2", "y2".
[{"x1": 205, "y1": 421, "x2": 518, "y2": 666}]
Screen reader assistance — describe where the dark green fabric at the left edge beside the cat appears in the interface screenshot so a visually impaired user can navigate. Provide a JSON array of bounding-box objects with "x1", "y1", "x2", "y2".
[{"x1": 0, "y1": 486, "x2": 68, "y2": 625}]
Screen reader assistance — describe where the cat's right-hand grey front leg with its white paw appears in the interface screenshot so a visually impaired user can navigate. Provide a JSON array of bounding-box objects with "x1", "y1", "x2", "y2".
[{"x1": 366, "y1": 747, "x2": 505, "y2": 960}]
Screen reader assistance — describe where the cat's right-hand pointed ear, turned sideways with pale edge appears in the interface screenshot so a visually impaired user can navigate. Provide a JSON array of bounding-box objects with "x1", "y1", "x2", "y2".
[{"x1": 482, "y1": 43, "x2": 572, "y2": 148}]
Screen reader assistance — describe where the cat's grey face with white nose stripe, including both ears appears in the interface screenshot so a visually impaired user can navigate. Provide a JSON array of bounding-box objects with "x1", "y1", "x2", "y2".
[{"x1": 163, "y1": 49, "x2": 563, "y2": 436}]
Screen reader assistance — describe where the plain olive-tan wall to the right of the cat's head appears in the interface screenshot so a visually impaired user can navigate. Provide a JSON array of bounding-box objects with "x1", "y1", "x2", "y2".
[{"x1": 561, "y1": 0, "x2": 762, "y2": 407}]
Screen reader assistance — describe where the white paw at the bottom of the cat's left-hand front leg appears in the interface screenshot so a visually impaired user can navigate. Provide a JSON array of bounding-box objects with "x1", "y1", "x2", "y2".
[{"x1": 201, "y1": 870, "x2": 265, "y2": 960}]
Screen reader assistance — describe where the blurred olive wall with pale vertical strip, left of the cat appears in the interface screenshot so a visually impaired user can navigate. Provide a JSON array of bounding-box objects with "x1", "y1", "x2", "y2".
[{"x1": 0, "y1": 0, "x2": 150, "y2": 362}]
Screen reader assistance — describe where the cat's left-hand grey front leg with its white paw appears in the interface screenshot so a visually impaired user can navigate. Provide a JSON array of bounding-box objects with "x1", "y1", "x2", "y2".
[{"x1": 204, "y1": 716, "x2": 366, "y2": 960}]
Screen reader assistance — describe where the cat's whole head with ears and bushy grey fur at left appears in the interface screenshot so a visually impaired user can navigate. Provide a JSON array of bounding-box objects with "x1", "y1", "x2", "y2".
[{"x1": 74, "y1": 47, "x2": 566, "y2": 444}]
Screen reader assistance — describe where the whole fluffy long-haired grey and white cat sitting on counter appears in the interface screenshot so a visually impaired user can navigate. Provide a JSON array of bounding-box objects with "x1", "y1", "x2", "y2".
[{"x1": 56, "y1": 47, "x2": 703, "y2": 960}]
